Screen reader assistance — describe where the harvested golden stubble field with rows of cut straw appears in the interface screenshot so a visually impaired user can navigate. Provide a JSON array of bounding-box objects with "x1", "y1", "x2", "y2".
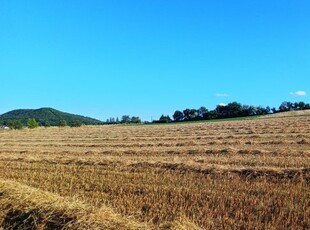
[{"x1": 0, "y1": 114, "x2": 310, "y2": 229}]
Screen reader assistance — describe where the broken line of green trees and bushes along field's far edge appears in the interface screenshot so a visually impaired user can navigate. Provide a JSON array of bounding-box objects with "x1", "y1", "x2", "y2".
[{"x1": 6, "y1": 101, "x2": 310, "y2": 129}]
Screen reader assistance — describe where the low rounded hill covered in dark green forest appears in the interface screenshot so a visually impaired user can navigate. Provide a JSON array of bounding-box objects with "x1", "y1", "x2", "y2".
[{"x1": 0, "y1": 108, "x2": 103, "y2": 126}]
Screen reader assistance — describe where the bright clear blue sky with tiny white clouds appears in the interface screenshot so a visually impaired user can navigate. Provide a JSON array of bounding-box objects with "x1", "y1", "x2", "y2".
[{"x1": 0, "y1": 0, "x2": 310, "y2": 120}]
